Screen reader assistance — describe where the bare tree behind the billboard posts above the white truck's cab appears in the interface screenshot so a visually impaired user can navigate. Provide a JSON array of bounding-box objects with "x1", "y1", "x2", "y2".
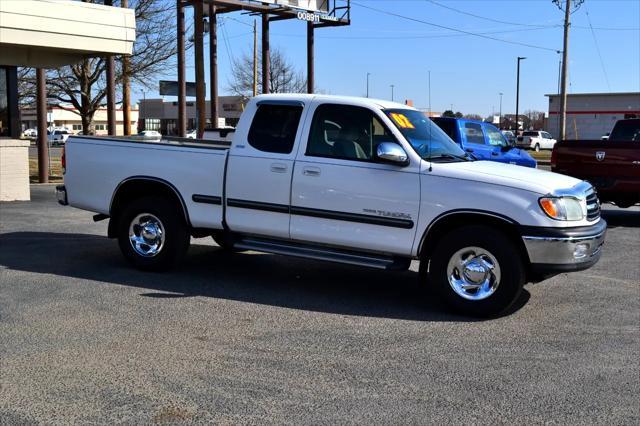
[{"x1": 227, "y1": 48, "x2": 307, "y2": 96}]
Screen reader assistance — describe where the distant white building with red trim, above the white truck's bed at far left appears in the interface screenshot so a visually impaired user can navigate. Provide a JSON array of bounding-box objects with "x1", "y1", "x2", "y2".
[{"x1": 20, "y1": 105, "x2": 138, "y2": 136}]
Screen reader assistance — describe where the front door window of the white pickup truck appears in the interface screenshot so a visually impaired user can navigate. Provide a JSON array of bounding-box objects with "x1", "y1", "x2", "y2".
[{"x1": 306, "y1": 104, "x2": 395, "y2": 161}]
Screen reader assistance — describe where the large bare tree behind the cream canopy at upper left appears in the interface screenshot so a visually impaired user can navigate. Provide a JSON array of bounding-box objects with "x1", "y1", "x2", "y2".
[{"x1": 19, "y1": 0, "x2": 182, "y2": 133}]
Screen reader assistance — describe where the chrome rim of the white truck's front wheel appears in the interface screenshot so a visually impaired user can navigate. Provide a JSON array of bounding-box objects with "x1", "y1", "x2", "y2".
[{"x1": 447, "y1": 247, "x2": 501, "y2": 301}]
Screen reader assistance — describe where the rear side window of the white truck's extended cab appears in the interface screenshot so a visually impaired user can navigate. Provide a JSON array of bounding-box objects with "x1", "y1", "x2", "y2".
[{"x1": 248, "y1": 104, "x2": 302, "y2": 154}]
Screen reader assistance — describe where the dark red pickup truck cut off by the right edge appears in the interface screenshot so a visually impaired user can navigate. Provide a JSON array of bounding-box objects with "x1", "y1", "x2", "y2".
[{"x1": 551, "y1": 118, "x2": 640, "y2": 208}]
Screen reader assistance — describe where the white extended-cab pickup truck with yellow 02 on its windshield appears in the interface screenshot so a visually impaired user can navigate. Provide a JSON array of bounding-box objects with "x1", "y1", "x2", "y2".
[{"x1": 57, "y1": 95, "x2": 606, "y2": 315}]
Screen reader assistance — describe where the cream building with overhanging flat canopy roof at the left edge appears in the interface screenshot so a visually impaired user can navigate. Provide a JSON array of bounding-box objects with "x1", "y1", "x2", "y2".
[{"x1": 0, "y1": 0, "x2": 136, "y2": 201}]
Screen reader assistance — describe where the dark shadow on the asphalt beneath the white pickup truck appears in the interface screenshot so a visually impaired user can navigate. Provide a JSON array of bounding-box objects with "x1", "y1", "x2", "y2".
[{"x1": 0, "y1": 232, "x2": 530, "y2": 321}]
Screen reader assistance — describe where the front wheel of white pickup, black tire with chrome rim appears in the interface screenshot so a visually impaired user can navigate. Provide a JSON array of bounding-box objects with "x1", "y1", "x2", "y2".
[{"x1": 428, "y1": 226, "x2": 525, "y2": 317}]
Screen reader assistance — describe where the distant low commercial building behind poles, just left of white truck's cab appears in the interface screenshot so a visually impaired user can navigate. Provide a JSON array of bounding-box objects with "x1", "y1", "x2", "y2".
[{"x1": 138, "y1": 96, "x2": 249, "y2": 135}]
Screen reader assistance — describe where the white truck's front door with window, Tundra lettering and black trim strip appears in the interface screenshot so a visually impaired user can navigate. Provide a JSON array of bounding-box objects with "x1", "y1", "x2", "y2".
[{"x1": 291, "y1": 104, "x2": 420, "y2": 255}]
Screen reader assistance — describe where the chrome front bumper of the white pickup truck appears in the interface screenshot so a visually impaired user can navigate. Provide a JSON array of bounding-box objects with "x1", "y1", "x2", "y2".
[{"x1": 521, "y1": 219, "x2": 607, "y2": 274}]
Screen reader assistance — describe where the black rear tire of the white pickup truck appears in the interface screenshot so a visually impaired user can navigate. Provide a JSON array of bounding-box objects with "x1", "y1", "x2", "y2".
[{"x1": 118, "y1": 196, "x2": 190, "y2": 271}]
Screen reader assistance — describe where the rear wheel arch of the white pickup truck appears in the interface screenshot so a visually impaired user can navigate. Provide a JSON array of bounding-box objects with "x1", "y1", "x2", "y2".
[{"x1": 107, "y1": 176, "x2": 191, "y2": 238}]
